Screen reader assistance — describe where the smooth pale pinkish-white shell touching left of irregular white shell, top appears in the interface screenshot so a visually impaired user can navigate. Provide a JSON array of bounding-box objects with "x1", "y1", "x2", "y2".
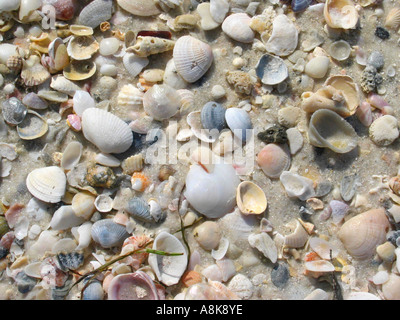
[{"x1": 221, "y1": 12, "x2": 255, "y2": 43}]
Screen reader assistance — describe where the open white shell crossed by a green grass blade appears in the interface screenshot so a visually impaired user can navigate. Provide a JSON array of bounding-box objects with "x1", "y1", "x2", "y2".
[{"x1": 148, "y1": 231, "x2": 188, "y2": 286}]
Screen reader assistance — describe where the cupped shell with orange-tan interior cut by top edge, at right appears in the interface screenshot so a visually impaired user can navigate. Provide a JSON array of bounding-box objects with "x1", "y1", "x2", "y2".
[{"x1": 324, "y1": 0, "x2": 358, "y2": 29}]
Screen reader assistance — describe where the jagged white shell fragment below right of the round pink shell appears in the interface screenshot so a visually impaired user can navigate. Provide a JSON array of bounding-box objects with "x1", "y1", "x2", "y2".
[{"x1": 279, "y1": 171, "x2": 315, "y2": 201}]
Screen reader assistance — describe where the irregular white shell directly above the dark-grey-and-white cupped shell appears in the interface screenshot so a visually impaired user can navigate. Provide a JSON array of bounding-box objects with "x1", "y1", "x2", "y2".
[{"x1": 265, "y1": 14, "x2": 298, "y2": 56}]
